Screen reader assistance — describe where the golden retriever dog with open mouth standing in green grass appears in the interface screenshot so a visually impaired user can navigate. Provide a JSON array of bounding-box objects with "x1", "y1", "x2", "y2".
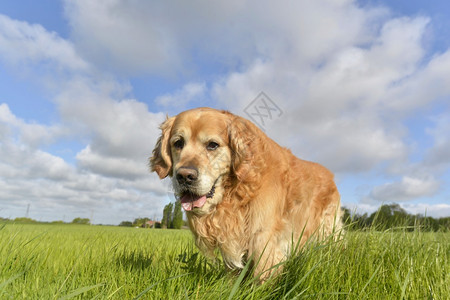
[{"x1": 150, "y1": 108, "x2": 341, "y2": 280}]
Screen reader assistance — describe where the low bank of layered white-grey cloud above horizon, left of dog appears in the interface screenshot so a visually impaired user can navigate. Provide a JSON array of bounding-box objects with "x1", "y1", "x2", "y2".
[{"x1": 0, "y1": 104, "x2": 168, "y2": 223}]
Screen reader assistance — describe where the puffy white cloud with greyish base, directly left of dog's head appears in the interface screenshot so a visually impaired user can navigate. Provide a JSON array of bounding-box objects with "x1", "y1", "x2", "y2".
[{"x1": 57, "y1": 81, "x2": 165, "y2": 179}]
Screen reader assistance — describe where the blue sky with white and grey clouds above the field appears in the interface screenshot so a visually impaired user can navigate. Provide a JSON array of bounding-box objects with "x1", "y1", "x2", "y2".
[{"x1": 0, "y1": 0, "x2": 450, "y2": 224}]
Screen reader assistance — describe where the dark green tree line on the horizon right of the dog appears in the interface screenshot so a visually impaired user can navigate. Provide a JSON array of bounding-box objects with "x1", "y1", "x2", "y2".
[{"x1": 343, "y1": 203, "x2": 450, "y2": 231}]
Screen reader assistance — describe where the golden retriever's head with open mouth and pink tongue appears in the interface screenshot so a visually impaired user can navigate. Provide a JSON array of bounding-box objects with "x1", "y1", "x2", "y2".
[{"x1": 150, "y1": 108, "x2": 250, "y2": 214}]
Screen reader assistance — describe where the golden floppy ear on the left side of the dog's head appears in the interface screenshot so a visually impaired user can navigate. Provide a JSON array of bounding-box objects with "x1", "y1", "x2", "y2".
[{"x1": 150, "y1": 117, "x2": 175, "y2": 179}]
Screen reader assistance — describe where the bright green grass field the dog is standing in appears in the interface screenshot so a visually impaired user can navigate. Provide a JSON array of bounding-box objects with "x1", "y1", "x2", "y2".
[{"x1": 0, "y1": 224, "x2": 450, "y2": 300}]
